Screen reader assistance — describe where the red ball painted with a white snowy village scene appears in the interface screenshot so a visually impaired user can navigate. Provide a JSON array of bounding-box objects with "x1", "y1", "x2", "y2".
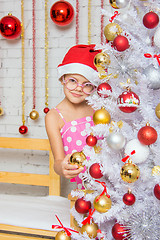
[{"x1": 117, "y1": 90, "x2": 140, "y2": 113}]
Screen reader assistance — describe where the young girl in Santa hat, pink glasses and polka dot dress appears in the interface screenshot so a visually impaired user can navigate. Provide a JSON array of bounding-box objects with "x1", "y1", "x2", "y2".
[{"x1": 45, "y1": 45, "x2": 100, "y2": 196}]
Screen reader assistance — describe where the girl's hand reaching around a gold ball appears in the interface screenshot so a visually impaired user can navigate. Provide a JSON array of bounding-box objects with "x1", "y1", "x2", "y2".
[{"x1": 62, "y1": 154, "x2": 84, "y2": 178}]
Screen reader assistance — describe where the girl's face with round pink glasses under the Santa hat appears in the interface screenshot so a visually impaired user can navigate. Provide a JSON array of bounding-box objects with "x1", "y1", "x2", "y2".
[{"x1": 61, "y1": 74, "x2": 95, "y2": 103}]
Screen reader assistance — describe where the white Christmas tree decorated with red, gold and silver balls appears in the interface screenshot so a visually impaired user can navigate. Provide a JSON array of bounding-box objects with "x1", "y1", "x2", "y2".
[{"x1": 71, "y1": 0, "x2": 160, "y2": 240}]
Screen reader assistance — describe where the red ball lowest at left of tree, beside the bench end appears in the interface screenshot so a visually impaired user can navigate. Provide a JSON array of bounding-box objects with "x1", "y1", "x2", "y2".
[{"x1": 75, "y1": 197, "x2": 91, "y2": 214}]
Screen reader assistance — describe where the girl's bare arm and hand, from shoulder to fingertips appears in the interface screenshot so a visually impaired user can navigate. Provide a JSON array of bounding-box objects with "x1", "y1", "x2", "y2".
[{"x1": 45, "y1": 109, "x2": 83, "y2": 178}]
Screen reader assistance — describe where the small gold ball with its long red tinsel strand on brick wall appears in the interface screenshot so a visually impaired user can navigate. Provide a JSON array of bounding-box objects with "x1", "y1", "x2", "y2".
[{"x1": 29, "y1": 0, "x2": 39, "y2": 120}]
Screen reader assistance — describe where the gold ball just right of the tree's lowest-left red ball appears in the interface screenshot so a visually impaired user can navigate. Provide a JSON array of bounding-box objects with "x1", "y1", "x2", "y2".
[{"x1": 93, "y1": 194, "x2": 112, "y2": 213}]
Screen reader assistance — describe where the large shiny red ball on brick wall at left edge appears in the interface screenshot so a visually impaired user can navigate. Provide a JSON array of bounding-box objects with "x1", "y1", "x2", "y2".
[{"x1": 0, "y1": 15, "x2": 21, "y2": 39}]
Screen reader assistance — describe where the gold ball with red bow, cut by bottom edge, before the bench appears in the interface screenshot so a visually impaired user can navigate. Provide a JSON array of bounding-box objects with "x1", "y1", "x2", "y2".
[{"x1": 52, "y1": 215, "x2": 78, "y2": 240}]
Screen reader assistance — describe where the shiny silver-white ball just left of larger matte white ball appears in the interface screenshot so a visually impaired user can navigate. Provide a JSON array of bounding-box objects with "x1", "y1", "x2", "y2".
[{"x1": 107, "y1": 132, "x2": 126, "y2": 150}]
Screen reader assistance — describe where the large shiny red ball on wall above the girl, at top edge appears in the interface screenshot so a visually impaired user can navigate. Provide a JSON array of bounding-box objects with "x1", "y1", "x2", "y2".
[{"x1": 50, "y1": 1, "x2": 74, "y2": 26}]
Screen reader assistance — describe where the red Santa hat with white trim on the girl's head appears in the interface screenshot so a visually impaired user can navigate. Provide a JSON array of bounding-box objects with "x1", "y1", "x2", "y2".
[{"x1": 57, "y1": 44, "x2": 101, "y2": 82}]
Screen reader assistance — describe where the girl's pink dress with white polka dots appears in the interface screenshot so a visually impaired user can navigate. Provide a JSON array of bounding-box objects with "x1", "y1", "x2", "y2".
[{"x1": 55, "y1": 108, "x2": 94, "y2": 189}]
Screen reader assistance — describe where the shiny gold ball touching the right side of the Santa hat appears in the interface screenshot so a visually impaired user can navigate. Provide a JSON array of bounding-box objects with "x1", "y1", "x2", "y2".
[{"x1": 94, "y1": 52, "x2": 111, "y2": 69}]
